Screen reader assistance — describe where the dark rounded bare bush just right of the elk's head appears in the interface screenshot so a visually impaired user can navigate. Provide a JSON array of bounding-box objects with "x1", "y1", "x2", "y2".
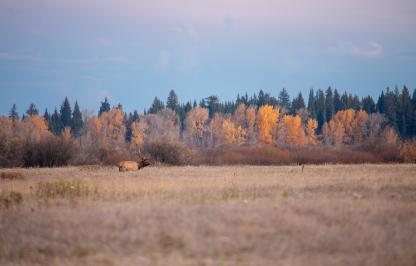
[{"x1": 143, "y1": 141, "x2": 191, "y2": 165}]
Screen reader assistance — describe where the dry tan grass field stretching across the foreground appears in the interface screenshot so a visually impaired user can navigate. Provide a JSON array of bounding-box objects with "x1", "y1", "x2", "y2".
[{"x1": 0, "y1": 165, "x2": 416, "y2": 265}]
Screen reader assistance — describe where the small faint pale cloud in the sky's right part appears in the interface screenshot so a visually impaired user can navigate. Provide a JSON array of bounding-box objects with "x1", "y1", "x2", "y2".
[{"x1": 328, "y1": 41, "x2": 383, "y2": 59}]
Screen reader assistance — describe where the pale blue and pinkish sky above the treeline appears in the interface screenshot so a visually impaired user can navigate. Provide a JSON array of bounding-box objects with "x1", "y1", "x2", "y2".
[{"x1": 0, "y1": 0, "x2": 416, "y2": 115}]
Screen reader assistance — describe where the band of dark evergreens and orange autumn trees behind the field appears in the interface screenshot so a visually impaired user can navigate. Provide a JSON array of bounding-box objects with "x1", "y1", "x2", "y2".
[{"x1": 0, "y1": 86, "x2": 416, "y2": 167}]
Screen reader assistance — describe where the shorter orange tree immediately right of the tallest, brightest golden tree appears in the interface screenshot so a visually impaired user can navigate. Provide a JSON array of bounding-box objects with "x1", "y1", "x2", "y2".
[{"x1": 283, "y1": 115, "x2": 305, "y2": 146}]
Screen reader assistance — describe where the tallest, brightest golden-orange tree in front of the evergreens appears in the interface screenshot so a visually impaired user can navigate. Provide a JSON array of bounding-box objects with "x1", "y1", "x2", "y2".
[{"x1": 257, "y1": 105, "x2": 279, "y2": 144}]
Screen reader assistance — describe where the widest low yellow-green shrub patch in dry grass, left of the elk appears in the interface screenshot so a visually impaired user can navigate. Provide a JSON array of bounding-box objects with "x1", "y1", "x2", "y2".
[{"x1": 36, "y1": 180, "x2": 97, "y2": 198}]
